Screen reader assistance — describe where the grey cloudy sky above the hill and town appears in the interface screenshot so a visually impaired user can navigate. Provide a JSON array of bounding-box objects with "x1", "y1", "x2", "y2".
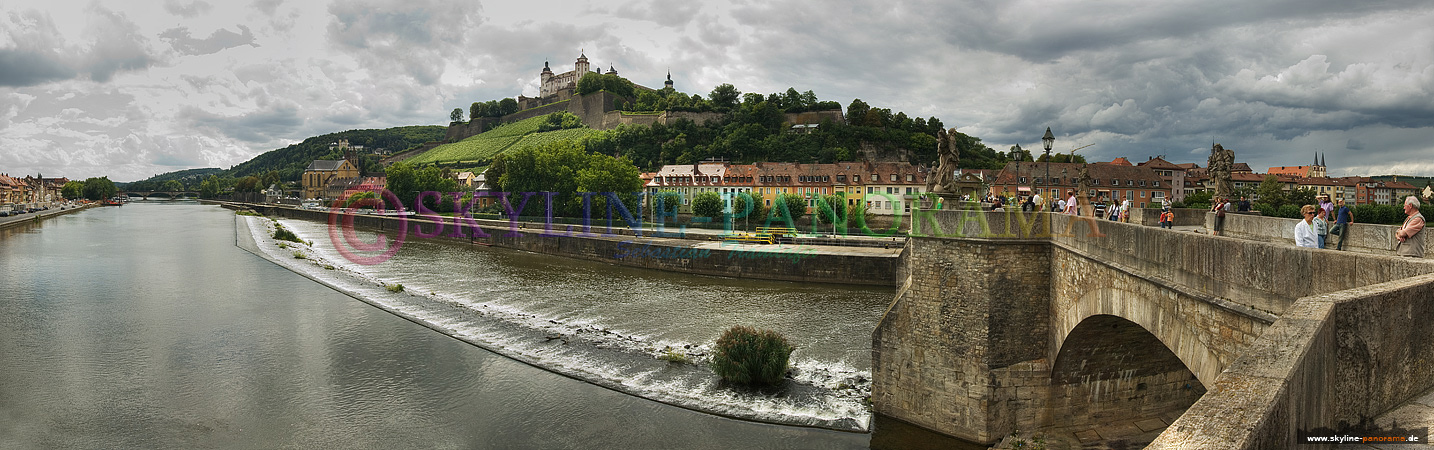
[{"x1": 0, "y1": 0, "x2": 1434, "y2": 181}]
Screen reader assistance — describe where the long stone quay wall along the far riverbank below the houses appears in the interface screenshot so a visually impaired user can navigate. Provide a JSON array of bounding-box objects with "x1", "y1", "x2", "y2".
[{"x1": 231, "y1": 204, "x2": 902, "y2": 287}]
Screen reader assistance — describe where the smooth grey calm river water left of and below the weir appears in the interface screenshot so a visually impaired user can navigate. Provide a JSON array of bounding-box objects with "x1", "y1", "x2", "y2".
[{"x1": 0, "y1": 202, "x2": 980, "y2": 449}]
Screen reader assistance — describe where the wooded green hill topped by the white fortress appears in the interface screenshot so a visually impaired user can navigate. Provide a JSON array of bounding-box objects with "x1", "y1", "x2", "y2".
[{"x1": 126, "y1": 50, "x2": 1021, "y2": 192}]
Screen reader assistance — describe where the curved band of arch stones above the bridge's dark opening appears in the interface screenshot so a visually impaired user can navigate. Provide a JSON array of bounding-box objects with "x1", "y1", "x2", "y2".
[{"x1": 1050, "y1": 287, "x2": 1228, "y2": 386}]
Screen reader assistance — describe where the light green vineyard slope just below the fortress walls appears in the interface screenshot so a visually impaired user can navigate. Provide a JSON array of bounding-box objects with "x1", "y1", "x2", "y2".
[{"x1": 403, "y1": 116, "x2": 597, "y2": 165}]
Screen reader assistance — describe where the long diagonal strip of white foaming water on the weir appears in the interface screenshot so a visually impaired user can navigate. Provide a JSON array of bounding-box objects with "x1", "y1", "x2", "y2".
[{"x1": 239, "y1": 216, "x2": 870, "y2": 431}]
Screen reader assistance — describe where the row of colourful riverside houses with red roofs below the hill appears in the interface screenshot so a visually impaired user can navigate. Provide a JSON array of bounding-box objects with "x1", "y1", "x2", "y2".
[{"x1": 642, "y1": 162, "x2": 992, "y2": 215}]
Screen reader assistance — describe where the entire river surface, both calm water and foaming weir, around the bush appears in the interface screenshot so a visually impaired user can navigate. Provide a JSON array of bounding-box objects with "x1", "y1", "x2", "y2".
[{"x1": 0, "y1": 202, "x2": 975, "y2": 449}]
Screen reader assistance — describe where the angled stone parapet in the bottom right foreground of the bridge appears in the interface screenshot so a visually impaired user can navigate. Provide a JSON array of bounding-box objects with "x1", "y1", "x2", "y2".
[{"x1": 1147, "y1": 272, "x2": 1434, "y2": 449}]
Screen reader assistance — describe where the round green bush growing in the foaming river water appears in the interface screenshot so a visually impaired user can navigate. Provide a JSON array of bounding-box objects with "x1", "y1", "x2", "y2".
[{"x1": 711, "y1": 325, "x2": 796, "y2": 386}]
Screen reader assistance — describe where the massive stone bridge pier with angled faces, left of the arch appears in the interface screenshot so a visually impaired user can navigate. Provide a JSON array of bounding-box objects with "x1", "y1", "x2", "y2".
[{"x1": 872, "y1": 238, "x2": 1051, "y2": 443}]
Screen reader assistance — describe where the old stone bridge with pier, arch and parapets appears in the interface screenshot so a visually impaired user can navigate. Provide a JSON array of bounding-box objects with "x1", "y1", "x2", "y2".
[{"x1": 872, "y1": 211, "x2": 1434, "y2": 449}]
